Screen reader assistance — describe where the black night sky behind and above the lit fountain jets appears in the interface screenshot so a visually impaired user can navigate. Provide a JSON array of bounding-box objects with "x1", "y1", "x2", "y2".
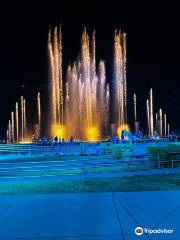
[{"x1": 0, "y1": 0, "x2": 180, "y2": 135}]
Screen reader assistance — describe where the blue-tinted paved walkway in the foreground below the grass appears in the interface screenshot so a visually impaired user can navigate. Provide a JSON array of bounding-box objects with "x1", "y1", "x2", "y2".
[{"x1": 0, "y1": 191, "x2": 180, "y2": 240}]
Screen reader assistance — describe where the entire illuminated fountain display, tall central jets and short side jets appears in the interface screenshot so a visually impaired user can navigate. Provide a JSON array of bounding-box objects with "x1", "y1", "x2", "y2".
[{"x1": 6, "y1": 27, "x2": 173, "y2": 142}]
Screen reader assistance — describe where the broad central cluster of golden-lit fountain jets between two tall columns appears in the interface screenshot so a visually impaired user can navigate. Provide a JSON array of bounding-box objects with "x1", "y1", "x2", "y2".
[{"x1": 65, "y1": 29, "x2": 109, "y2": 140}]
